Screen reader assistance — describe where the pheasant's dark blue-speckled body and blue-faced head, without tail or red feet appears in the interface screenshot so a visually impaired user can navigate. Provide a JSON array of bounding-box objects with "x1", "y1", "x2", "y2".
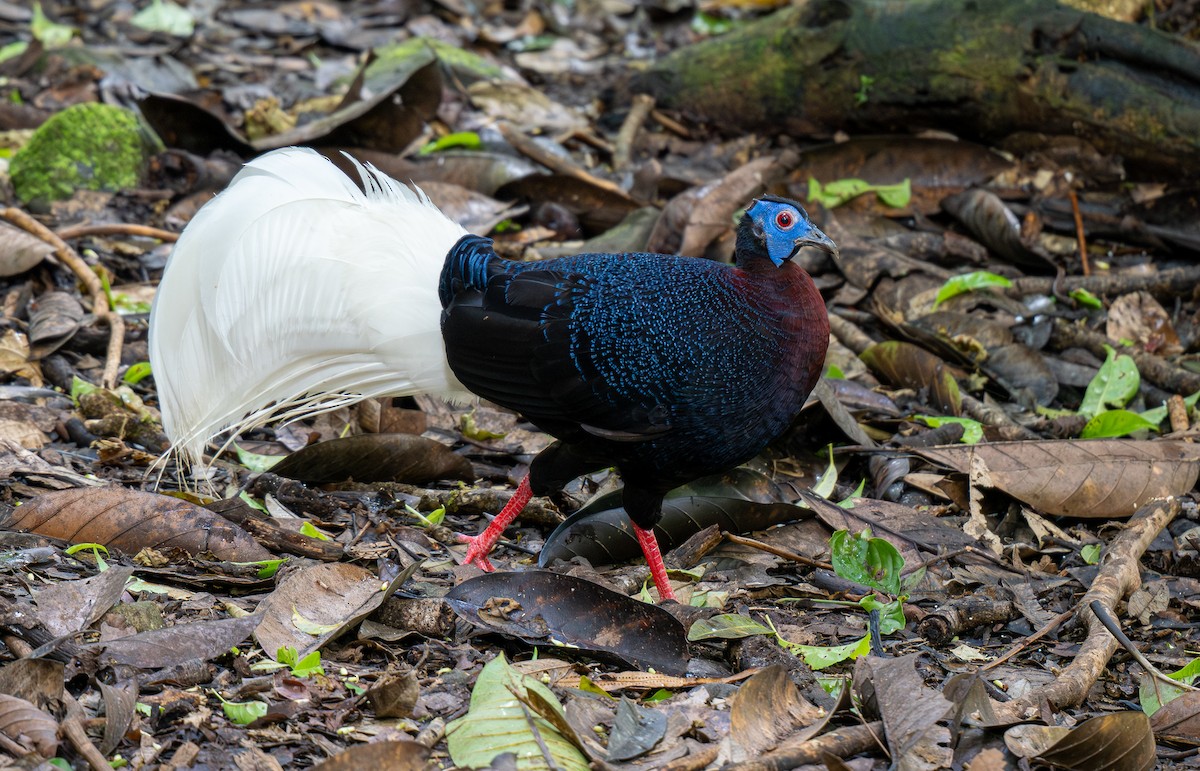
[{"x1": 439, "y1": 197, "x2": 834, "y2": 595}]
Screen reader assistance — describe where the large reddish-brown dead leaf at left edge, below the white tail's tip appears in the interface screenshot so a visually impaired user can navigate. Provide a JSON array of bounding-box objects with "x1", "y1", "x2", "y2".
[{"x1": 0, "y1": 488, "x2": 272, "y2": 562}]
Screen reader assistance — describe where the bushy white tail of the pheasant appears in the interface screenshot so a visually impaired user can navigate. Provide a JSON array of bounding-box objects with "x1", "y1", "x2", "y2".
[{"x1": 150, "y1": 148, "x2": 469, "y2": 461}]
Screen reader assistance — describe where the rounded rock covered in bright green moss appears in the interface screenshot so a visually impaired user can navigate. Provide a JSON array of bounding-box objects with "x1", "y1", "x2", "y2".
[{"x1": 8, "y1": 103, "x2": 161, "y2": 203}]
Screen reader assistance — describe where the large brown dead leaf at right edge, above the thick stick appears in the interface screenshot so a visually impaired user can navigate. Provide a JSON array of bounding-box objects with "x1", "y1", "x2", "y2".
[{"x1": 913, "y1": 440, "x2": 1200, "y2": 518}]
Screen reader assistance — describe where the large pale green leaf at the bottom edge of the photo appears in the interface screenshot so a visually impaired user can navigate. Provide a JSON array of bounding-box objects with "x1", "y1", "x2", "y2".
[{"x1": 446, "y1": 655, "x2": 589, "y2": 771}]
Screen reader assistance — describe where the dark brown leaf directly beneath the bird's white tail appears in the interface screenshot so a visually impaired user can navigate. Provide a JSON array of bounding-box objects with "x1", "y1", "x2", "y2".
[{"x1": 271, "y1": 434, "x2": 475, "y2": 484}]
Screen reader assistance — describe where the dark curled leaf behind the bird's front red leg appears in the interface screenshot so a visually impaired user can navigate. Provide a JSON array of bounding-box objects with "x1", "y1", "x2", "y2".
[{"x1": 538, "y1": 470, "x2": 809, "y2": 567}]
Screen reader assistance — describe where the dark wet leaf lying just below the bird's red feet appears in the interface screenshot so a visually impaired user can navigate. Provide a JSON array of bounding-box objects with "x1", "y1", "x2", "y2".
[{"x1": 445, "y1": 570, "x2": 688, "y2": 675}]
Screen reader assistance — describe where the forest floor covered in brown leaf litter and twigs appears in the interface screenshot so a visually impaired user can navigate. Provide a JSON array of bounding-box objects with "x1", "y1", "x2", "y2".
[{"x1": 0, "y1": 0, "x2": 1200, "y2": 771}]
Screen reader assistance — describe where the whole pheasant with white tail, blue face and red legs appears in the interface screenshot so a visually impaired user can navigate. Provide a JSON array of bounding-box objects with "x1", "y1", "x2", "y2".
[{"x1": 149, "y1": 148, "x2": 836, "y2": 602}]
